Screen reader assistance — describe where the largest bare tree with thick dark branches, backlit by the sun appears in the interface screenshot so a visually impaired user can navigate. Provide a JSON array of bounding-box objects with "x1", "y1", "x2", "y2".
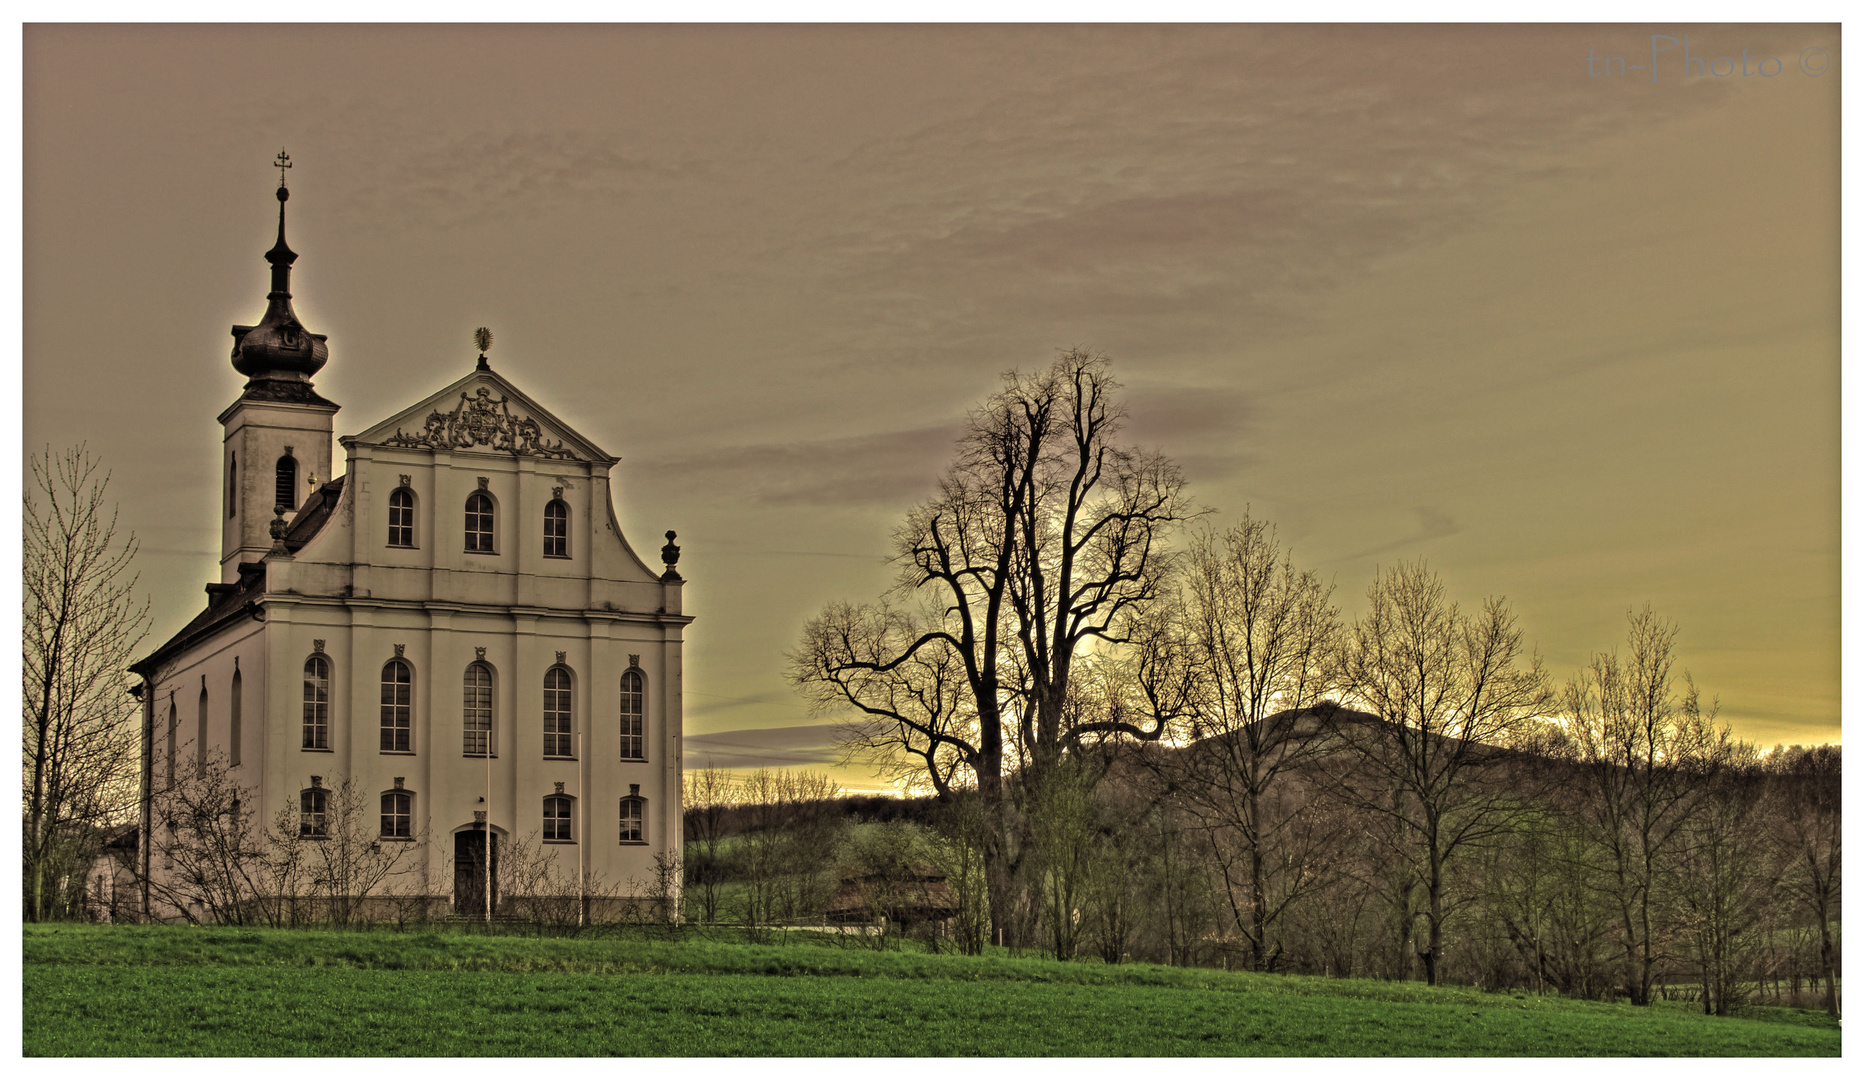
[{"x1": 790, "y1": 349, "x2": 1187, "y2": 938}]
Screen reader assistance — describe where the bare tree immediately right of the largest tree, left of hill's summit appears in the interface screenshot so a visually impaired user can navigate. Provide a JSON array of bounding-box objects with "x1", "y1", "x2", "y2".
[{"x1": 1135, "y1": 515, "x2": 1340, "y2": 972}]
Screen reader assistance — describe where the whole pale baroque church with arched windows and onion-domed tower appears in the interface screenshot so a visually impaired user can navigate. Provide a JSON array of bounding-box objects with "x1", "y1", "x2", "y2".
[{"x1": 132, "y1": 166, "x2": 692, "y2": 918}]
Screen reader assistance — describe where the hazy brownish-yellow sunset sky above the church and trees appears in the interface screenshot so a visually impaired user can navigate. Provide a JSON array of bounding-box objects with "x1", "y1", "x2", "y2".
[{"x1": 22, "y1": 24, "x2": 1840, "y2": 791}]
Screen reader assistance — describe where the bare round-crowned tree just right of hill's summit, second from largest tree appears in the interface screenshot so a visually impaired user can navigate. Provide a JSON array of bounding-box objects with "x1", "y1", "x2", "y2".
[{"x1": 1335, "y1": 563, "x2": 1549, "y2": 985}]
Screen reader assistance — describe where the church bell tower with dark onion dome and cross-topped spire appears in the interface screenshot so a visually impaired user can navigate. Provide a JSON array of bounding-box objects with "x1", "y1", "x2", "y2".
[{"x1": 220, "y1": 151, "x2": 337, "y2": 582}]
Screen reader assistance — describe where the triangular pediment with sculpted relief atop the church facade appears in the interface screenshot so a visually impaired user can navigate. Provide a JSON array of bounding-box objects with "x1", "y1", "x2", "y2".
[{"x1": 354, "y1": 369, "x2": 615, "y2": 464}]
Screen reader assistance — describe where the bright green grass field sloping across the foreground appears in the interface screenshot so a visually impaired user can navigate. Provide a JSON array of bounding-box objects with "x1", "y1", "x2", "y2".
[{"x1": 22, "y1": 927, "x2": 1840, "y2": 1056}]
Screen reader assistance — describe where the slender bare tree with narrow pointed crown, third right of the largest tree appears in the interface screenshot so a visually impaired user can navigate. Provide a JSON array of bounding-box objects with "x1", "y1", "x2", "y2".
[{"x1": 1560, "y1": 608, "x2": 1732, "y2": 1005}]
